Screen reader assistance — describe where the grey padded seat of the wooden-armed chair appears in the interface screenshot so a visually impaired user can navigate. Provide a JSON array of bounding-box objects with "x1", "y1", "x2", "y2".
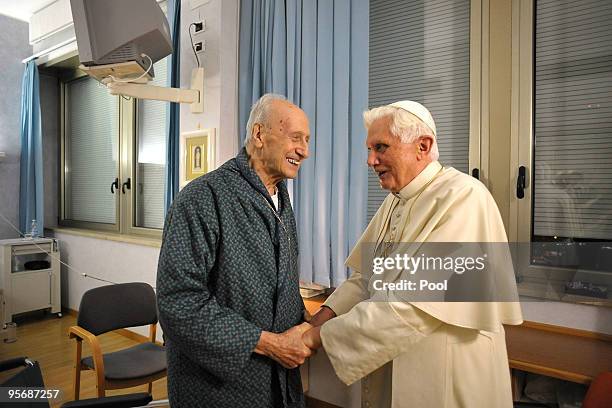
[{"x1": 81, "y1": 342, "x2": 166, "y2": 380}]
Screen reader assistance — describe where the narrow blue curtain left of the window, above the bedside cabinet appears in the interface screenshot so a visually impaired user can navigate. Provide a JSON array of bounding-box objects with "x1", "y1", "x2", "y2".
[{"x1": 19, "y1": 60, "x2": 45, "y2": 236}]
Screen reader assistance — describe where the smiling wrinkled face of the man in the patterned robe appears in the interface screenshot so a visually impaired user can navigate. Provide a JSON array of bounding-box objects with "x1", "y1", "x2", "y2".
[{"x1": 261, "y1": 101, "x2": 310, "y2": 180}]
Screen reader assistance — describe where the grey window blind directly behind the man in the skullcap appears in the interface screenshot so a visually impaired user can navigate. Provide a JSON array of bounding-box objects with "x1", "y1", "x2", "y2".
[{"x1": 368, "y1": 0, "x2": 470, "y2": 219}]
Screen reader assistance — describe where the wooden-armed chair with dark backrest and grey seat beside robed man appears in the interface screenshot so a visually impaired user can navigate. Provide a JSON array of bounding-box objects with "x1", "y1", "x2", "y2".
[{"x1": 69, "y1": 282, "x2": 166, "y2": 400}]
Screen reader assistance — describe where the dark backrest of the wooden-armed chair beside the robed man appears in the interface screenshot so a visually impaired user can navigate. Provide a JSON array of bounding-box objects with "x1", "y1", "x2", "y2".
[{"x1": 77, "y1": 282, "x2": 157, "y2": 336}]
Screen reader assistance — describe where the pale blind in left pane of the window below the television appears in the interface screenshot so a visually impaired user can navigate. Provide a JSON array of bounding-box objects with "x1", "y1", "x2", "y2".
[{"x1": 65, "y1": 77, "x2": 119, "y2": 224}]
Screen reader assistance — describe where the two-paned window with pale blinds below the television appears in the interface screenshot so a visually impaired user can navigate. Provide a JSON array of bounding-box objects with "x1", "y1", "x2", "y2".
[{"x1": 60, "y1": 59, "x2": 167, "y2": 235}]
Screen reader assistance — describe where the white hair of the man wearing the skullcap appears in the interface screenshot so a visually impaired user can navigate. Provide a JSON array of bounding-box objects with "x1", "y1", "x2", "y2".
[{"x1": 363, "y1": 106, "x2": 440, "y2": 160}]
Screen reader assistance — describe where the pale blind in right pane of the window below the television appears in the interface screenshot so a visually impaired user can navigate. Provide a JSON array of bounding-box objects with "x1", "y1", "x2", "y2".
[{"x1": 135, "y1": 58, "x2": 168, "y2": 229}]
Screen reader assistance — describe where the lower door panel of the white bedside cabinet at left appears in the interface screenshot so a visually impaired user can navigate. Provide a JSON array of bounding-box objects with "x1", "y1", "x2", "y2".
[{"x1": 10, "y1": 269, "x2": 51, "y2": 315}]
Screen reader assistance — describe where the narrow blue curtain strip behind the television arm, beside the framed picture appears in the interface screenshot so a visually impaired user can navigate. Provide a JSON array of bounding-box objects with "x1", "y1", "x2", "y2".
[{"x1": 164, "y1": 0, "x2": 181, "y2": 212}]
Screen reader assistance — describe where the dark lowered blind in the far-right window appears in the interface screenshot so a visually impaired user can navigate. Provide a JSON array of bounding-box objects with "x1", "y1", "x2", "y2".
[{"x1": 533, "y1": 0, "x2": 612, "y2": 240}]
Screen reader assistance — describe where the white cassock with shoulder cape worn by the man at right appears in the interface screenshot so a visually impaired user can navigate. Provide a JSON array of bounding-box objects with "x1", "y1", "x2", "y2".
[{"x1": 321, "y1": 162, "x2": 522, "y2": 408}]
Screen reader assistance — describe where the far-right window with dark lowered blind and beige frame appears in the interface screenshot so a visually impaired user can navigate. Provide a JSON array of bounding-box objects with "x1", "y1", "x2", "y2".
[{"x1": 513, "y1": 0, "x2": 612, "y2": 300}]
